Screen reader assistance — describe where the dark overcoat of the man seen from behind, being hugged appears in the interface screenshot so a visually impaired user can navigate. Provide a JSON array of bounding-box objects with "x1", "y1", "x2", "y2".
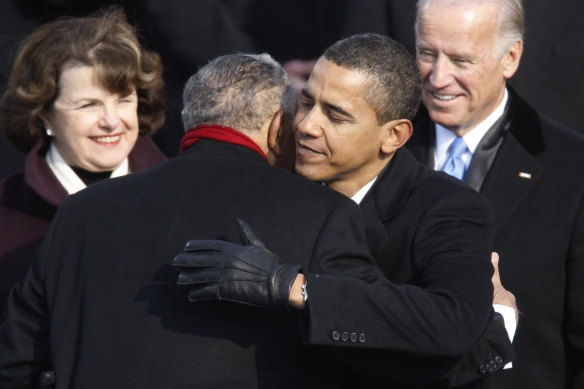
[{"x1": 0, "y1": 140, "x2": 372, "y2": 389}]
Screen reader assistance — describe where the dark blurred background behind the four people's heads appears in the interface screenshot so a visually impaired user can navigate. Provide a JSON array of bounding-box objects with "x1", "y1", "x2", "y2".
[{"x1": 0, "y1": 0, "x2": 584, "y2": 178}]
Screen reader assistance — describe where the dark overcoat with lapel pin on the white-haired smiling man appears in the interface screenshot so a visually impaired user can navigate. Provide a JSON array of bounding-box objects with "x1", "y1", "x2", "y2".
[{"x1": 408, "y1": 88, "x2": 584, "y2": 389}]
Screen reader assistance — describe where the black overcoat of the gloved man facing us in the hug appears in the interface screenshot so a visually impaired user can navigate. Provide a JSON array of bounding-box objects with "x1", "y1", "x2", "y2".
[{"x1": 309, "y1": 149, "x2": 514, "y2": 388}]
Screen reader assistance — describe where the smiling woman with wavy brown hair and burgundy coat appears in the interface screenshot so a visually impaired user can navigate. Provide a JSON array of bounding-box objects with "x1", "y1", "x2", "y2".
[{"x1": 0, "y1": 8, "x2": 166, "y2": 316}]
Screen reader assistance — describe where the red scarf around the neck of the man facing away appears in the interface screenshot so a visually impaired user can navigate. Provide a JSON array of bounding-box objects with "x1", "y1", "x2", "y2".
[{"x1": 180, "y1": 124, "x2": 268, "y2": 161}]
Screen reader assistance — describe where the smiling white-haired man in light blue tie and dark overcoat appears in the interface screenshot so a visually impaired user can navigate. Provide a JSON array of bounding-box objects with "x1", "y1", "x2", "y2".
[{"x1": 407, "y1": 0, "x2": 584, "y2": 389}]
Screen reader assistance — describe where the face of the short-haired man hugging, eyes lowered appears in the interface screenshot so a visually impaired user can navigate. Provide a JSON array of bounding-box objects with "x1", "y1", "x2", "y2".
[{"x1": 294, "y1": 57, "x2": 387, "y2": 197}]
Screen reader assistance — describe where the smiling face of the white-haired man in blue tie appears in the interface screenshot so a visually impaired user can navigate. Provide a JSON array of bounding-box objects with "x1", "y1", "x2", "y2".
[{"x1": 416, "y1": 3, "x2": 514, "y2": 135}]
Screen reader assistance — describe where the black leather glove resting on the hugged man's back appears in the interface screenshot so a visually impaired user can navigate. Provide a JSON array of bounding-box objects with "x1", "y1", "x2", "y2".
[{"x1": 172, "y1": 219, "x2": 300, "y2": 310}]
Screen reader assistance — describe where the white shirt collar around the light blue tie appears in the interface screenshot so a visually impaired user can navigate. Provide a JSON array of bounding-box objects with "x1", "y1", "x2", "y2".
[{"x1": 434, "y1": 89, "x2": 509, "y2": 170}]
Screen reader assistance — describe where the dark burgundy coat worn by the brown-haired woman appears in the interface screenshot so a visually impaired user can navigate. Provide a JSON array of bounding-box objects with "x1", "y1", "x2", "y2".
[{"x1": 0, "y1": 136, "x2": 167, "y2": 316}]
